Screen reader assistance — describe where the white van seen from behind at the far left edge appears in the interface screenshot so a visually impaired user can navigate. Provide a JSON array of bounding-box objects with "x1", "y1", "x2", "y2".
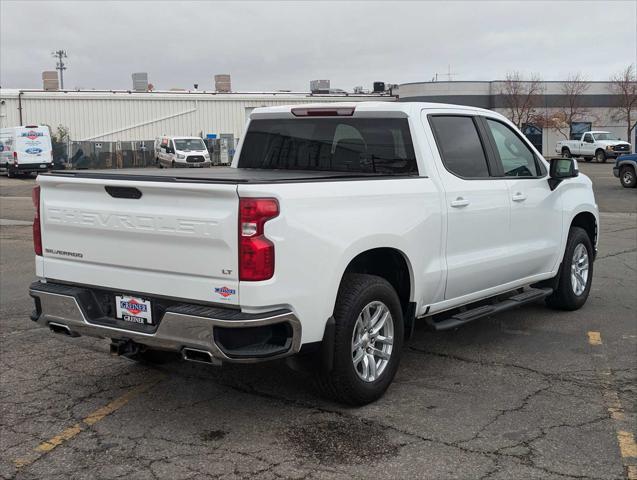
[{"x1": 0, "y1": 125, "x2": 53, "y2": 177}]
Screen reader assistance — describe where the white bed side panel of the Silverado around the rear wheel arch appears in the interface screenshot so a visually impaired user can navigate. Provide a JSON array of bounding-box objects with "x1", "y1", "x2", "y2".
[{"x1": 238, "y1": 177, "x2": 444, "y2": 343}]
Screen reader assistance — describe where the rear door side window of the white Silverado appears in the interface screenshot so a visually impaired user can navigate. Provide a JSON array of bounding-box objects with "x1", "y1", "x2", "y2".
[{"x1": 429, "y1": 115, "x2": 489, "y2": 178}]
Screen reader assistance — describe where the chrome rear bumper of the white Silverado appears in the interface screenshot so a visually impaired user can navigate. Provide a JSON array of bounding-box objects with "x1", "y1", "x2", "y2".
[{"x1": 29, "y1": 282, "x2": 301, "y2": 363}]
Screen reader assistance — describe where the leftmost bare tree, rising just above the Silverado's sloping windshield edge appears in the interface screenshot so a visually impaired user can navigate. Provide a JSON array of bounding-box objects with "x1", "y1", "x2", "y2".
[{"x1": 500, "y1": 72, "x2": 544, "y2": 128}]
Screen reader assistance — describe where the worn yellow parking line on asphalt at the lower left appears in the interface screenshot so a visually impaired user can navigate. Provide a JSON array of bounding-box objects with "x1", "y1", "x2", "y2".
[{"x1": 13, "y1": 376, "x2": 163, "y2": 468}]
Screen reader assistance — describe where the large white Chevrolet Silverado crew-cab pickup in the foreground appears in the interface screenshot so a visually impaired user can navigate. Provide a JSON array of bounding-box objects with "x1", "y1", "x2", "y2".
[{"x1": 30, "y1": 102, "x2": 599, "y2": 404}]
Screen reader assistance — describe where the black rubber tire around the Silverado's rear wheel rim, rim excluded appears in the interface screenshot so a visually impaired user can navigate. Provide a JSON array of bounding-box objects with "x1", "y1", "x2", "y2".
[{"x1": 317, "y1": 274, "x2": 404, "y2": 405}]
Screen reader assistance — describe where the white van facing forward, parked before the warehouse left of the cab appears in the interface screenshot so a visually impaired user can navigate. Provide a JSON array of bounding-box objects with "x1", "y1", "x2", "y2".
[{"x1": 155, "y1": 136, "x2": 211, "y2": 168}]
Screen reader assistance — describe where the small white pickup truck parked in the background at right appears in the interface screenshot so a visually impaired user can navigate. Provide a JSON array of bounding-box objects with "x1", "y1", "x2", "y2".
[{"x1": 555, "y1": 131, "x2": 630, "y2": 163}]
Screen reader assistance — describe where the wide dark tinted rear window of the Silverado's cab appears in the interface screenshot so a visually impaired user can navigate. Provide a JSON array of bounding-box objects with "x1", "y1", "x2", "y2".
[{"x1": 238, "y1": 118, "x2": 418, "y2": 174}]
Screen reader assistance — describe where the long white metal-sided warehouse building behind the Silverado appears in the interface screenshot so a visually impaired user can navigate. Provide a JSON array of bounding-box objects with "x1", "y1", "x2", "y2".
[{"x1": 0, "y1": 89, "x2": 396, "y2": 142}]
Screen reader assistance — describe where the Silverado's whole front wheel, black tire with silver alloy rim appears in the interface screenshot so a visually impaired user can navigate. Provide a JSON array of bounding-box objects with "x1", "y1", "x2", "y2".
[{"x1": 546, "y1": 227, "x2": 594, "y2": 310}]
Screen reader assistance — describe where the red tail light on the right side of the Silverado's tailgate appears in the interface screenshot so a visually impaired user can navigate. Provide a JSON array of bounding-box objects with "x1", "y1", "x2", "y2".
[{"x1": 239, "y1": 198, "x2": 279, "y2": 282}]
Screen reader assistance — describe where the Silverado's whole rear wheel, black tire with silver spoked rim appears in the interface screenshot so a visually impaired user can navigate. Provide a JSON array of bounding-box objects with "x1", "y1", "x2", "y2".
[{"x1": 318, "y1": 274, "x2": 404, "y2": 405}]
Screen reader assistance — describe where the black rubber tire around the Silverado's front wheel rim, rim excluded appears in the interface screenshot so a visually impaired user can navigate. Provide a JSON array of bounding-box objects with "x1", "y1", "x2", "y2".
[{"x1": 546, "y1": 227, "x2": 594, "y2": 310}]
